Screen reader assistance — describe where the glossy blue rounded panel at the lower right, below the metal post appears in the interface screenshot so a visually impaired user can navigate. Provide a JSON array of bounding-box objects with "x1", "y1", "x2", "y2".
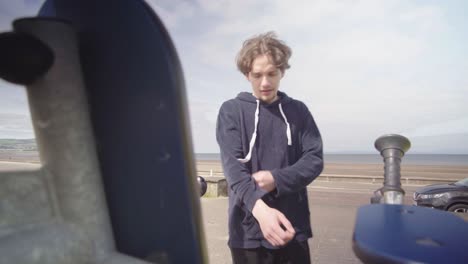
[{"x1": 353, "y1": 204, "x2": 468, "y2": 263}]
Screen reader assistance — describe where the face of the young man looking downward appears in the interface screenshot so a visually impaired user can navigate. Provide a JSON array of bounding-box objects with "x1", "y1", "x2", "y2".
[{"x1": 247, "y1": 55, "x2": 283, "y2": 104}]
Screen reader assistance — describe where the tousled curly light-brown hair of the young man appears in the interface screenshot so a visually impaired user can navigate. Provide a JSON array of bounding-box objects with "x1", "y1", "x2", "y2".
[{"x1": 236, "y1": 31, "x2": 292, "y2": 75}]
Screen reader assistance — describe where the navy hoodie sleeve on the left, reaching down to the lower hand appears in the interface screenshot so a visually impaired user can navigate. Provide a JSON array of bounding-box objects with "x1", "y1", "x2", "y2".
[{"x1": 216, "y1": 101, "x2": 266, "y2": 212}]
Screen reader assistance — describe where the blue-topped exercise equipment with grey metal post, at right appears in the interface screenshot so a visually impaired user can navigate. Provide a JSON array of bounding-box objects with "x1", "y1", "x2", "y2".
[{"x1": 353, "y1": 135, "x2": 468, "y2": 263}]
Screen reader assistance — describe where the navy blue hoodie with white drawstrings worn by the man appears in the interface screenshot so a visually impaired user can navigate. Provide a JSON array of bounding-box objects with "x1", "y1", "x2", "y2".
[{"x1": 216, "y1": 92, "x2": 323, "y2": 248}]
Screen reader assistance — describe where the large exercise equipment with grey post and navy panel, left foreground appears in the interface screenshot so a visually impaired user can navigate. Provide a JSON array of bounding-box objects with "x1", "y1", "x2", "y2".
[{"x1": 0, "y1": 0, "x2": 207, "y2": 263}]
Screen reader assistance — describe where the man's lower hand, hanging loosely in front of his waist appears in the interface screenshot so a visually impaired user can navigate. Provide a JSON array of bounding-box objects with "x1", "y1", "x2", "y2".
[{"x1": 252, "y1": 199, "x2": 296, "y2": 247}]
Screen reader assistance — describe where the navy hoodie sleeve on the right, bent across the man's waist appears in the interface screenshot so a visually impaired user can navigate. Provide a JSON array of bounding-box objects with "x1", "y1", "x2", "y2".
[{"x1": 271, "y1": 102, "x2": 323, "y2": 197}]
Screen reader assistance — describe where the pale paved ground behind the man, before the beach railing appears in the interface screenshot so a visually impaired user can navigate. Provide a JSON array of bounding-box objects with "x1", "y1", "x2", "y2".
[{"x1": 201, "y1": 182, "x2": 424, "y2": 264}]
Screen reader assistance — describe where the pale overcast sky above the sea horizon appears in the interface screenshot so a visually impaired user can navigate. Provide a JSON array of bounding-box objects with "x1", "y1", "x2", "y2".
[{"x1": 0, "y1": 0, "x2": 468, "y2": 154}]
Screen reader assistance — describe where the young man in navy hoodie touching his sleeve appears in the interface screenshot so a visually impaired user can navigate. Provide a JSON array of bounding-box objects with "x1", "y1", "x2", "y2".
[{"x1": 216, "y1": 32, "x2": 323, "y2": 264}]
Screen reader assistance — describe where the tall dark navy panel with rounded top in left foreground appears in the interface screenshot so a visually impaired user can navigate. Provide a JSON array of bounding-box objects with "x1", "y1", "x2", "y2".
[{"x1": 39, "y1": 0, "x2": 204, "y2": 263}]
